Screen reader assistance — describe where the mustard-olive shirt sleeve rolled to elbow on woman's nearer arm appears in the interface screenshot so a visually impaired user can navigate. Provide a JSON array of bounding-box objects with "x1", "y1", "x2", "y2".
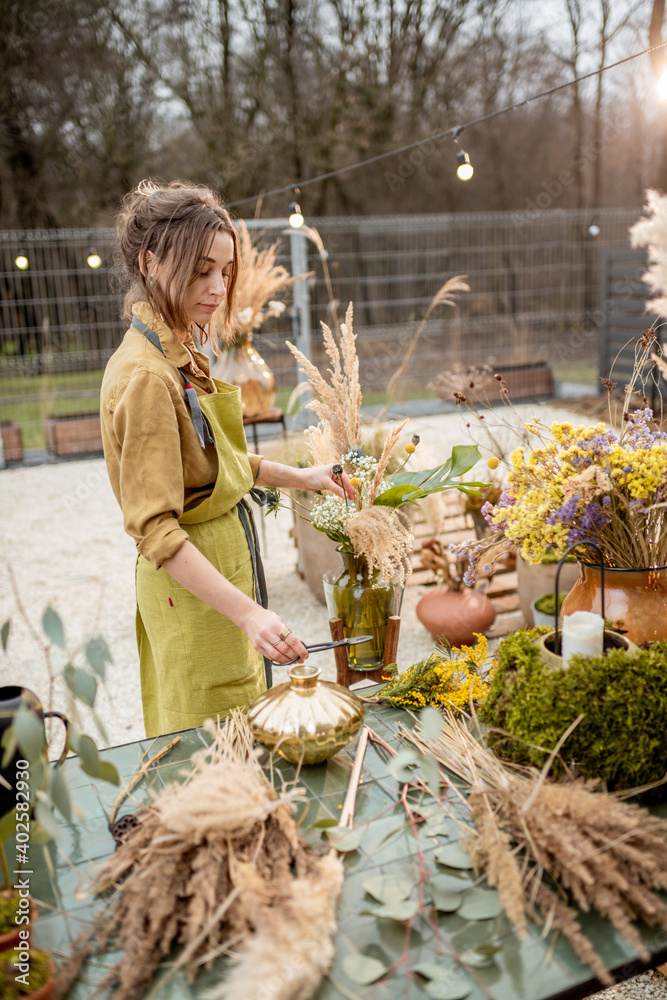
[{"x1": 113, "y1": 370, "x2": 188, "y2": 569}]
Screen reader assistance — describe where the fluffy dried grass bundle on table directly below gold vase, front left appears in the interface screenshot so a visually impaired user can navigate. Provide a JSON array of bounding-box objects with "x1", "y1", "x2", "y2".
[{"x1": 60, "y1": 712, "x2": 343, "y2": 1000}]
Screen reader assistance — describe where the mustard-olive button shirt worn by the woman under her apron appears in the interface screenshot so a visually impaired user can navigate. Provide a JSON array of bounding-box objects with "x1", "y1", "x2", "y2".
[{"x1": 100, "y1": 302, "x2": 261, "y2": 569}]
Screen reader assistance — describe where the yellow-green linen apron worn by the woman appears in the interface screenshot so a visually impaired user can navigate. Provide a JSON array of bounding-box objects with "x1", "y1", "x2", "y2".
[{"x1": 136, "y1": 379, "x2": 266, "y2": 737}]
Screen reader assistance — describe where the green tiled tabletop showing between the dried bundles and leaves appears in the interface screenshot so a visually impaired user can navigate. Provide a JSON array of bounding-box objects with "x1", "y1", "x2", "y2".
[{"x1": 15, "y1": 705, "x2": 667, "y2": 1000}]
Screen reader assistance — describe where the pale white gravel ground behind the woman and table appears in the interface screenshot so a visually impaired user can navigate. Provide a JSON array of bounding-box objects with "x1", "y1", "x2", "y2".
[{"x1": 0, "y1": 405, "x2": 667, "y2": 1000}]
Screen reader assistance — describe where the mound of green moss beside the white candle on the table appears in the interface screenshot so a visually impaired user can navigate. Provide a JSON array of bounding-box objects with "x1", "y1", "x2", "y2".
[{"x1": 479, "y1": 630, "x2": 667, "y2": 788}]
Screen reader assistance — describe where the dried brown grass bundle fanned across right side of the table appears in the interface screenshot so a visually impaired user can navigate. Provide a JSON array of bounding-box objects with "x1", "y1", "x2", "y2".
[{"x1": 403, "y1": 712, "x2": 667, "y2": 984}]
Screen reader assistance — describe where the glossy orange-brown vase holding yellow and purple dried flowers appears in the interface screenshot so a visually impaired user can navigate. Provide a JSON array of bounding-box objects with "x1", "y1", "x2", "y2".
[{"x1": 561, "y1": 563, "x2": 667, "y2": 645}]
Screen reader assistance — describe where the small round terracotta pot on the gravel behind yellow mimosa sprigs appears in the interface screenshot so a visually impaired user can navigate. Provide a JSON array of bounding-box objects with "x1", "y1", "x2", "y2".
[{"x1": 416, "y1": 587, "x2": 496, "y2": 647}]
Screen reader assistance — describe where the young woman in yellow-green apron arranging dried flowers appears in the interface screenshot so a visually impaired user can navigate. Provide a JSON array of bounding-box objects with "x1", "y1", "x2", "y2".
[{"x1": 101, "y1": 182, "x2": 352, "y2": 737}]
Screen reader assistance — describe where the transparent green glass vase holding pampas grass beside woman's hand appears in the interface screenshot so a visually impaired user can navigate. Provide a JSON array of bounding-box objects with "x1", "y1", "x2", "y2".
[{"x1": 322, "y1": 549, "x2": 403, "y2": 670}]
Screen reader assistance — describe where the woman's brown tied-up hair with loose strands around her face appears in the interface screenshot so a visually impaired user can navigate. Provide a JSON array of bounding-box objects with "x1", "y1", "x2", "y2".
[{"x1": 116, "y1": 181, "x2": 239, "y2": 354}]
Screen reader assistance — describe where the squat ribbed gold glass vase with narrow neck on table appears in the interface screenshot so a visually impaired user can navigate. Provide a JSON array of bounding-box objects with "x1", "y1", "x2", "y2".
[{"x1": 248, "y1": 664, "x2": 364, "y2": 764}]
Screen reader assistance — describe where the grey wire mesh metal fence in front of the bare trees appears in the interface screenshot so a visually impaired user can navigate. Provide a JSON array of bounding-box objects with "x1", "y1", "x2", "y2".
[{"x1": 0, "y1": 209, "x2": 640, "y2": 456}]
